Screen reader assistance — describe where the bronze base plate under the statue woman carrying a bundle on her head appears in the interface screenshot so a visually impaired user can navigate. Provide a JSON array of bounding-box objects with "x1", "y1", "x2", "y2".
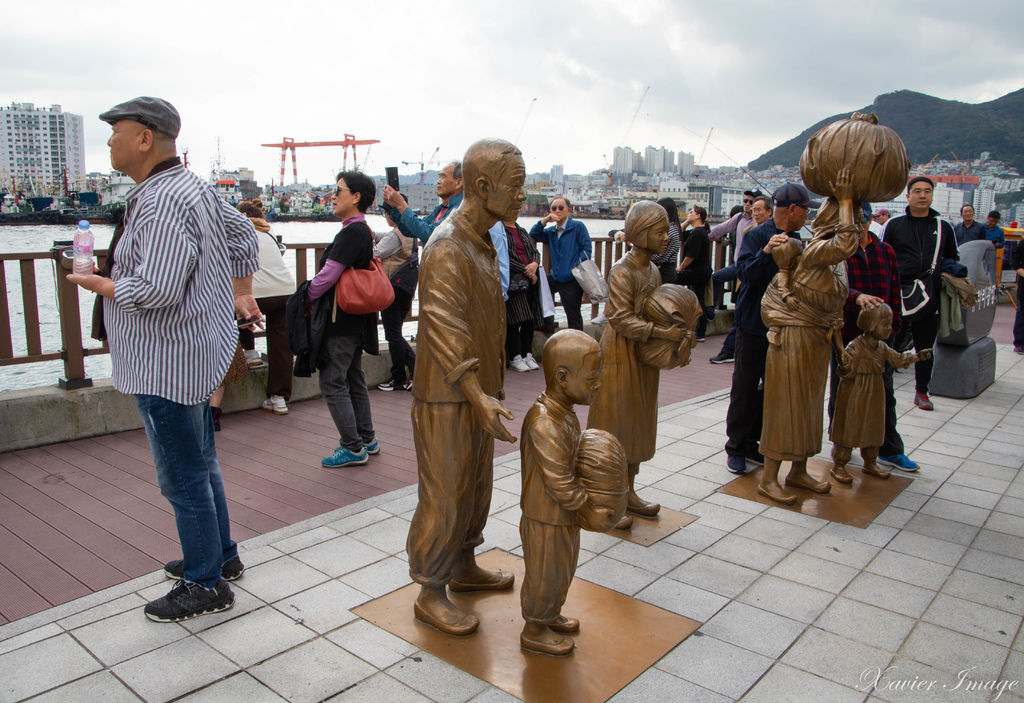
[{"x1": 719, "y1": 458, "x2": 911, "y2": 528}]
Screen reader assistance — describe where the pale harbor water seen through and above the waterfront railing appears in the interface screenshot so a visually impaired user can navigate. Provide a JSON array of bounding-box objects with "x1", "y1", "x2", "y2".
[{"x1": 0, "y1": 215, "x2": 624, "y2": 391}]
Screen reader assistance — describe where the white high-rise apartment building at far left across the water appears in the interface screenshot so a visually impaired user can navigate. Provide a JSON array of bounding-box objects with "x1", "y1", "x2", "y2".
[{"x1": 0, "y1": 102, "x2": 85, "y2": 194}]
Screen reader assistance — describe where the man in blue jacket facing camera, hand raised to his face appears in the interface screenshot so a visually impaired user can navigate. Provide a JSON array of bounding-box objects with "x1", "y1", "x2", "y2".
[{"x1": 529, "y1": 195, "x2": 593, "y2": 329}]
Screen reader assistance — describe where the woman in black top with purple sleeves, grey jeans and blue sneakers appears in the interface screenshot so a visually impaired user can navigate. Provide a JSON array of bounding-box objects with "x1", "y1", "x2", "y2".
[{"x1": 306, "y1": 171, "x2": 380, "y2": 469}]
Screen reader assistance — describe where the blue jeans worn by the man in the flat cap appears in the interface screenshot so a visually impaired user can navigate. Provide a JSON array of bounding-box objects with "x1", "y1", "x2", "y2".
[{"x1": 135, "y1": 395, "x2": 239, "y2": 588}]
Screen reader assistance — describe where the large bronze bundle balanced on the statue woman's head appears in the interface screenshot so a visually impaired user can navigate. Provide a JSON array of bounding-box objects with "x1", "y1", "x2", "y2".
[{"x1": 800, "y1": 113, "x2": 910, "y2": 203}]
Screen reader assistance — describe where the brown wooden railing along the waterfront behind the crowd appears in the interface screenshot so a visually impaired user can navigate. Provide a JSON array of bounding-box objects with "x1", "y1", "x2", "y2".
[{"x1": 0, "y1": 236, "x2": 730, "y2": 390}]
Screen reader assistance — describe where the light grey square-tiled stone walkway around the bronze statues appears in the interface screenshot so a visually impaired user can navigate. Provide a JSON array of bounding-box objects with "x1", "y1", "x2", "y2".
[{"x1": 0, "y1": 346, "x2": 1024, "y2": 703}]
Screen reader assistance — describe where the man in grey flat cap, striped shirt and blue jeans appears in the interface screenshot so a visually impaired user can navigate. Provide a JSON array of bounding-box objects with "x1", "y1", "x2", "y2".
[{"x1": 68, "y1": 97, "x2": 260, "y2": 622}]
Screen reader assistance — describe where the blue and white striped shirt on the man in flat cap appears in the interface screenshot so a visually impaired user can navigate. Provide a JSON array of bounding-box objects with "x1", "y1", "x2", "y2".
[{"x1": 103, "y1": 166, "x2": 259, "y2": 405}]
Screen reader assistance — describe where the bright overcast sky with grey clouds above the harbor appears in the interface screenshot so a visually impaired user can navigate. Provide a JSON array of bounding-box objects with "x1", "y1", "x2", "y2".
[{"x1": 0, "y1": 0, "x2": 1024, "y2": 183}]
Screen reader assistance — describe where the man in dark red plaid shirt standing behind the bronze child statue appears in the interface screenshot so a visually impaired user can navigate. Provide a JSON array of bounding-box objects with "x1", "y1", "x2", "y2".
[{"x1": 828, "y1": 203, "x2": 919, "y2": 471}]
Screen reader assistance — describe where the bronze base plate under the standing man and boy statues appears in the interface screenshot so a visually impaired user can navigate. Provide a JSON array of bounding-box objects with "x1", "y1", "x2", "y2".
[{"x1": 352, "y1": 550, "x2": 701, "y2": 703}]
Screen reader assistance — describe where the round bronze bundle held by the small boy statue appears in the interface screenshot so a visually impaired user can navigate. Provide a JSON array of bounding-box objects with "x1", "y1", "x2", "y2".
[{"x1": 575, "y1": 430, "x2": 629, "y2": 532}]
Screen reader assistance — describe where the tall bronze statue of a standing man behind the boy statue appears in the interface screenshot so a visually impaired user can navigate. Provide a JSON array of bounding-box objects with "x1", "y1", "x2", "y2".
[{"x1": 407, "y1": 139, "x2": 526, "y2": 634}]
